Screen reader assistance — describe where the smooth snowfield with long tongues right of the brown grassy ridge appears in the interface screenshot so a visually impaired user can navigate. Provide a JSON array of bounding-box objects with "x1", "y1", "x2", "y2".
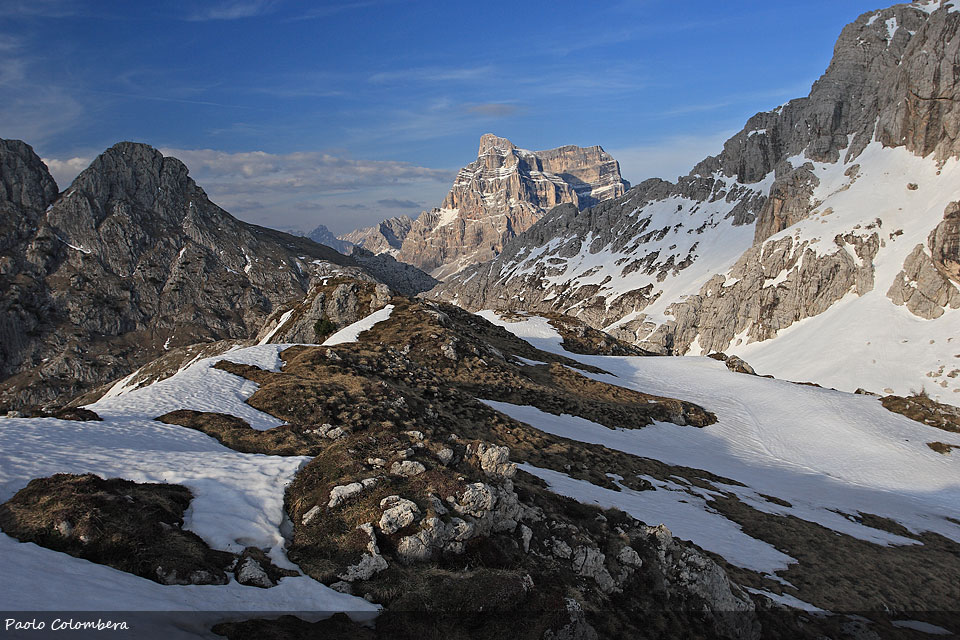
[{"x1": 481, "y1": 312, "x2": 960, "y2": 575}]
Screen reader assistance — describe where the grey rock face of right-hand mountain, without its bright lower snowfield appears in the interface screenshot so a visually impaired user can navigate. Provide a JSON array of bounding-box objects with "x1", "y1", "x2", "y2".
[{"x1": 429, "y1": 2, "x2": 960, "y2": 360}]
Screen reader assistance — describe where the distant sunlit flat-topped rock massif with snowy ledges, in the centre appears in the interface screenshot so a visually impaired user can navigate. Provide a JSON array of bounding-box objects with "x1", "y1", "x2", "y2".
[{"x1": 356, "y1": 133, "x2": 629, "y2": 279}]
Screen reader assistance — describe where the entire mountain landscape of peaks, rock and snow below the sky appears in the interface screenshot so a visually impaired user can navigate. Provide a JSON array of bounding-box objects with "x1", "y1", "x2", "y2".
[{"x1": 0, "y1": 0, "x2": 960, "y2": 640}]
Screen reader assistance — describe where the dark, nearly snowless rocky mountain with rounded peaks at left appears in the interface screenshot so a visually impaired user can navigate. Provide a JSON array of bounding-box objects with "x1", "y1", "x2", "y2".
[{"x1": 0, "y1": 141, "x2": 394, "y2": 410}]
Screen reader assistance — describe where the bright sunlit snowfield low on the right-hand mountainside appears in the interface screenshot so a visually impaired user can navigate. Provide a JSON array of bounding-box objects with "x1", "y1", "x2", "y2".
[{"x1": 728, "y1": 143, "x2": 960, "y2": 404}]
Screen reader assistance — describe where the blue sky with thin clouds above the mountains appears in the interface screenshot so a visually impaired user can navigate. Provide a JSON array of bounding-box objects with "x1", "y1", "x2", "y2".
[{"x1": 0, "y1": 0, "x2": 887, "y2": 233}]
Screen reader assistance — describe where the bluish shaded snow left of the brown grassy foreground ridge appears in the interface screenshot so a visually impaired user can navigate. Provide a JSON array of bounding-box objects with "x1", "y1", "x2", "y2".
[{"x1": 0, "y1": 344, "x2": 377, "y2": 637}]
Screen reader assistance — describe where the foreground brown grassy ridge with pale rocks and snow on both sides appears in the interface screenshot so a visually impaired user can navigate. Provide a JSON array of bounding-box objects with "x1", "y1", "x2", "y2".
[{"x1": 0, "y1": 286, "x2": 960, "y2": 640}]
